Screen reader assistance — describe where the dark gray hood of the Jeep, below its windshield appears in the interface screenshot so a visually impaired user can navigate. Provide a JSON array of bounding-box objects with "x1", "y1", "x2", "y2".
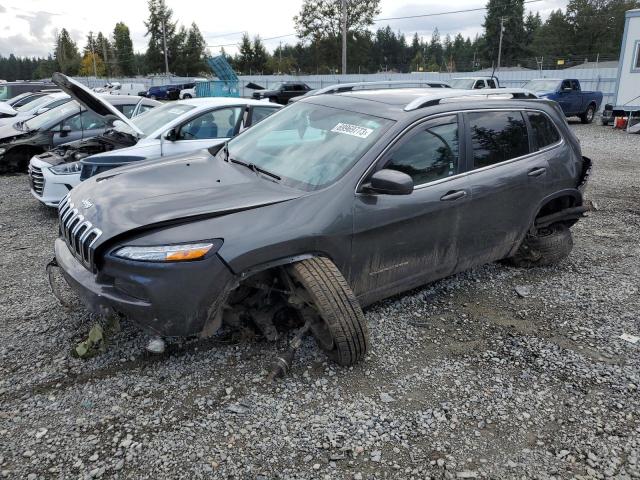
[{"x1": 70, "y1": 150, "x2": 305, "y2": 247}]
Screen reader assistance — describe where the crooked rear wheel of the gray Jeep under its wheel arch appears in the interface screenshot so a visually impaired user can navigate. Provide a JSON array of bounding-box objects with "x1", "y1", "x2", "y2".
[{"x1": 507, "y1": 223, "x2": 573, "y2": 268}]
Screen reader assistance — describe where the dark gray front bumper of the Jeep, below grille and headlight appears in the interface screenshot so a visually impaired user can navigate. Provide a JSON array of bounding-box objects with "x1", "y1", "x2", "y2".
[{"x1": 55, "y1": 238, "x2": 235, "y2": 337}]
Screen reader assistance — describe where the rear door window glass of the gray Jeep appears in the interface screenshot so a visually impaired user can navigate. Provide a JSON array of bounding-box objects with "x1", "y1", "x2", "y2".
[{"x1": 467, "y1": 112, "x2": 529, "y2": 168}]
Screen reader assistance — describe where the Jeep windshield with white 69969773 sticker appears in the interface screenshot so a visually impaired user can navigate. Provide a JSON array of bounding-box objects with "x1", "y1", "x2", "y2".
[{"x1": 225, "y1": 103, "x2": 393, "y2": 190}]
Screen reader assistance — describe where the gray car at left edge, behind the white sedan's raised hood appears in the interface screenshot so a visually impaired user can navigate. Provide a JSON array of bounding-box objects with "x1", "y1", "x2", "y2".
[{"x1": 0, "y1": 74, "x2": 159, "y2": 173}]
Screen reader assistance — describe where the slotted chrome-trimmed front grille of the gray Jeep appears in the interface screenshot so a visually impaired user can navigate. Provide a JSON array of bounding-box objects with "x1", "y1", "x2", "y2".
[{"x1": 58, "y1": 195, "x2": 102, "y2": 270}]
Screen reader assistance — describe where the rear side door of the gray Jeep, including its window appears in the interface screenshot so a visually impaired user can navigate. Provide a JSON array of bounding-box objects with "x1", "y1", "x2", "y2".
[{"x1": 456, "y1": 110, "x2": 549, "y2": 271}]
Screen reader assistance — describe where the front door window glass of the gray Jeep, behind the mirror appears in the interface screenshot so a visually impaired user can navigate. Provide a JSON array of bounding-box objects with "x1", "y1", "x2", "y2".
[{"x1": 384, "y1": 115, "x2": 460, "y2": 185}]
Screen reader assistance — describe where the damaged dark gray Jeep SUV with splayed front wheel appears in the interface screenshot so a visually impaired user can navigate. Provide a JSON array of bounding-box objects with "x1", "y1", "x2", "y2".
[{"x1": 50, "y1": 84, "x2": 591, "y2": 365}]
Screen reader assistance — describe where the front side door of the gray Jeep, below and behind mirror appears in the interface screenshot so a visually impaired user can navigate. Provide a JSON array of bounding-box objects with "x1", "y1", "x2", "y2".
[{"x1": 352, "y1": 114, "x2": 470, "y2": 297}]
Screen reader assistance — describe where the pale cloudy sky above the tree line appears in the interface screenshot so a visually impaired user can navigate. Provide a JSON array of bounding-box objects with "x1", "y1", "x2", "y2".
[{"x1": 0, "y1": 0, "x2": 567, "y2": 56}]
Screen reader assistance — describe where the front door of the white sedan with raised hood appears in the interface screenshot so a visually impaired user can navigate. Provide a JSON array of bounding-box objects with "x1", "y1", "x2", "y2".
[{"x1": 162, "y1": 106, "x2": 242, "y2": 156}]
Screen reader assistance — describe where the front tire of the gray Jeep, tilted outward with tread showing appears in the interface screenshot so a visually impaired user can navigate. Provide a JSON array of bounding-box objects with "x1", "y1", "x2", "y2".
[{"x1": 291, "y1": 258, "x2": 369, "y2": 366}]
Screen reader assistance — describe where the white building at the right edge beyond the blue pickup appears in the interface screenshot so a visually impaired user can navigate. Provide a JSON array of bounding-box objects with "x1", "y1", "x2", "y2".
[{"x1": 613, "y1": 9, "x2": 640, "y2": 116}]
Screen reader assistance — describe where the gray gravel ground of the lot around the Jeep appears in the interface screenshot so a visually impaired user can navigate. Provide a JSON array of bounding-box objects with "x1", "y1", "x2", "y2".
[{"x1": 0, "y1": 124, "x2": 640, "y2": 479}]
